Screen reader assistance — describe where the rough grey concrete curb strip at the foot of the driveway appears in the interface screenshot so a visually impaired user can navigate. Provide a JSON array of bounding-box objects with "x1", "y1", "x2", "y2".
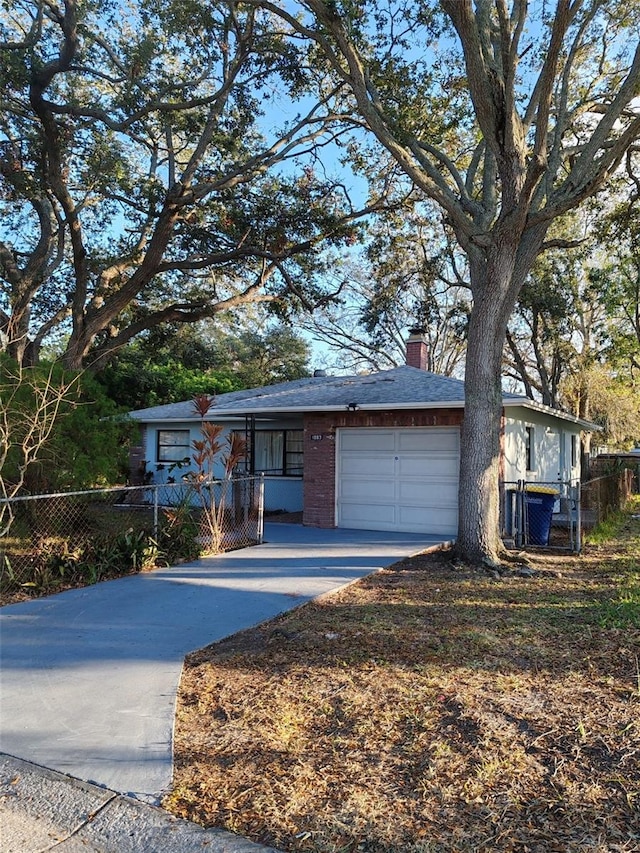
[{"x1": 0, "y1": 753, "x2": 280, "y2": 853}]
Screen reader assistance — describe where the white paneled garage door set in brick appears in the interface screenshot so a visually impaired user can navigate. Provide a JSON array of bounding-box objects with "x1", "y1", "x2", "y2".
[{"x1": 336, "y1": 427, "x2": 460, "y2": 536}]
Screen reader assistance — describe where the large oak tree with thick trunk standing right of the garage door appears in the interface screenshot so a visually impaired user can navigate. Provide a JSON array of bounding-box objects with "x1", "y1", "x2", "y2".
[{"x1": 255, "y1": 0, "x2": 640, "y2": 560}]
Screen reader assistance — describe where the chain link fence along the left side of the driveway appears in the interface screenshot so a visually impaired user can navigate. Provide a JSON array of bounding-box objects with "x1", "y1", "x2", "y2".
[{"x1": 0, "y1": 477, "x2": 264, "y2": 603}]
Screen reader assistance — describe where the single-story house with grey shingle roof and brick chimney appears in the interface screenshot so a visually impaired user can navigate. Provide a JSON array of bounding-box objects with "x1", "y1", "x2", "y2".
[{"x1": 131, "y1": 330, "x2": 593, "y2": 536}]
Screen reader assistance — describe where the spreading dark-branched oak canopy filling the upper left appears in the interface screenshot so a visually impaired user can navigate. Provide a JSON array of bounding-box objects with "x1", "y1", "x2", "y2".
[{"x1": 0, "y1": 0, "x2": 380, "y2": 368}]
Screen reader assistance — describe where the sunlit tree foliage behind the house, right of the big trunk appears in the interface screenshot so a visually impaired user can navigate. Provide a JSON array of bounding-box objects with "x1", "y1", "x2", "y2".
[{"x1": 506, "y1": 223, "x2": 640, "y2": 451}]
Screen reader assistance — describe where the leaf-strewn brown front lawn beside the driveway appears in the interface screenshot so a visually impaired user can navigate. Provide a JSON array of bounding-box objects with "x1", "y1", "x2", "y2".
[{"x1": 164, "y1": 500, "x2": 640, "y2": 853}]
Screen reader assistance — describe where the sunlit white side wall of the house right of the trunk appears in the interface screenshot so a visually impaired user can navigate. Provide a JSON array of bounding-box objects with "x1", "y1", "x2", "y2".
[{"x1": 504, "y1": 408, "x2": 580, "y2": 483}]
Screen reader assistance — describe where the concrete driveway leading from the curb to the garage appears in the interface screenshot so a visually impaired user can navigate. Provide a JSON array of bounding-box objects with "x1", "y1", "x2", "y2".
[{"x1": 0, "y1": 524, "x2": 443, "y2": 802}]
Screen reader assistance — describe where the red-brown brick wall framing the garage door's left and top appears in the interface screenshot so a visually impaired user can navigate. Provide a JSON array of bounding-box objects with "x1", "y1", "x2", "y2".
[{"x1": 303, "y1": 409, "x2": 463, "y2": 527}]
